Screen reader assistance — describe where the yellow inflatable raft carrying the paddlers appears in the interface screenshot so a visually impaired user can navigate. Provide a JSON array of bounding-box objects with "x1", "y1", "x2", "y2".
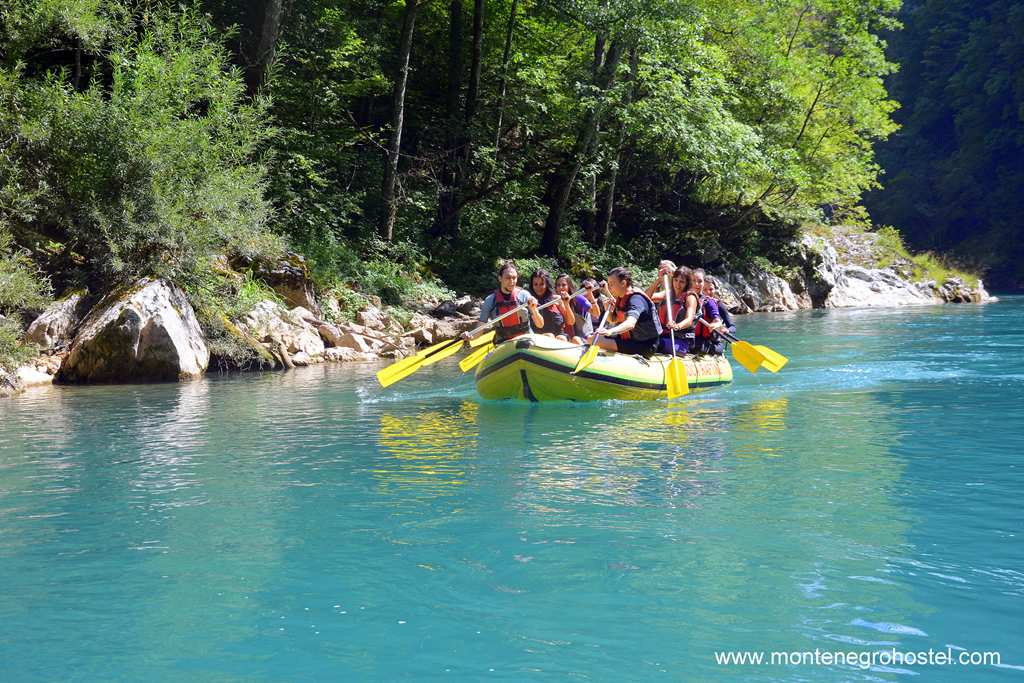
[{"x1": 476, "y1": 335, "x2": 732, "y2": 400}]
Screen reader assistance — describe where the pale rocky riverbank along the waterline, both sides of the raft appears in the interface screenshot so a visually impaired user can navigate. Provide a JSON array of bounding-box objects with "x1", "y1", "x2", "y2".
[{"x1": 0, "y1": 229, "x2": 993, "y2": 396}]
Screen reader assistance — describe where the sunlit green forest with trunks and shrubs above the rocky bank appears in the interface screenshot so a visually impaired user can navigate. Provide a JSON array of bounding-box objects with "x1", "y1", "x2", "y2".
[{"x1": 0, "y1": 0, "x2": 899, "y2": 368}]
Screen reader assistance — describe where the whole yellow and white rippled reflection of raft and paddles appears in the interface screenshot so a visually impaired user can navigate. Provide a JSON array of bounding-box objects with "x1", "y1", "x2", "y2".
[{"x1": 373, "y1": 398, "x2": 788, "y2": 507}]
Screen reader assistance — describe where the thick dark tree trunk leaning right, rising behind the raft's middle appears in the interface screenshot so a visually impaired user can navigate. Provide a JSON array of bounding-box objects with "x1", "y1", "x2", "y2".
[{"x1": 540, "y1": 40, "x2": 624, "y2": 256}]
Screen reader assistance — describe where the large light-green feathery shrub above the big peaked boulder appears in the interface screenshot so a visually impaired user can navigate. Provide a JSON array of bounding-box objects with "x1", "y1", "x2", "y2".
[{"x1": 0, "y1": 2, "x2": 283, "y2": 291}]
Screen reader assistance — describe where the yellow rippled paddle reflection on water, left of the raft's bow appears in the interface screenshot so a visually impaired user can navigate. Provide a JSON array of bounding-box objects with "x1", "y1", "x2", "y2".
[{"x1": 374, "y1": 401, "x2": 479, "y2": 495}]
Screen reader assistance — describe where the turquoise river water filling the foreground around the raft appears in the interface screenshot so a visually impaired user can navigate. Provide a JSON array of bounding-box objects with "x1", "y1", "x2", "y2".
[{"x1": 0, "y1": 297, "x2": 1024, "y2": 682}]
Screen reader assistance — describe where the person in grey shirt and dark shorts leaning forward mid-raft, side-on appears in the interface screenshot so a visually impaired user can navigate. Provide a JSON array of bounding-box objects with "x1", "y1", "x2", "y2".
[{"x1": 594, "y1": 267, "x2": 662, "y2": 357}]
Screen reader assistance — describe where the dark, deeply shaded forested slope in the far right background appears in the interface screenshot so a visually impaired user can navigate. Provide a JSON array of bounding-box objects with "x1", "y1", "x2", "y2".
[{"x1": 865, "y1": 0, "x2": 1024, "y2": 290}]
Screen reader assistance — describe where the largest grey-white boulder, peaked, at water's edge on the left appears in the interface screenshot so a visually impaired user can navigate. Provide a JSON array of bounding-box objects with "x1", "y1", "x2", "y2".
[{"x1": 57, "y1": 278, "x2": 210, "y2": 382}]
